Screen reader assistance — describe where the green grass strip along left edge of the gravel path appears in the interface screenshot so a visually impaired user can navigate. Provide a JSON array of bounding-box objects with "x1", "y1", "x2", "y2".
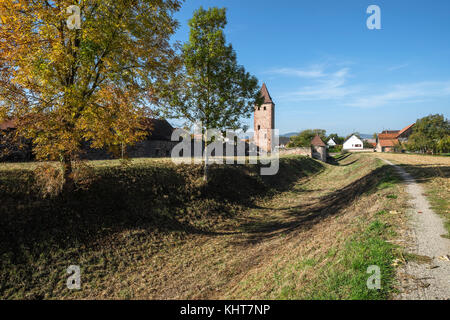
[{"x1": 300, "y1": 168, "x2": 400, "y2": 300}]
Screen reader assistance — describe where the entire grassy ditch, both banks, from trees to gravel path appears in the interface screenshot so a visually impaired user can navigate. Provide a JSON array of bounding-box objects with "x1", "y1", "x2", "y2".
[{"x1": 0, "y1": 155, "x2": 407, "y2": 299}]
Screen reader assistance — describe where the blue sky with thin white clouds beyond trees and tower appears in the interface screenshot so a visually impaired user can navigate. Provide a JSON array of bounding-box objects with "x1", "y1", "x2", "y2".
[{"x1": 171, "y1": 0, "x2": 450, "y2": 135}]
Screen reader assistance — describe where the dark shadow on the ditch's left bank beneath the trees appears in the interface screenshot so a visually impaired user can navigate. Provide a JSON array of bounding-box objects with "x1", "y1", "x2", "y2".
[{"x1": 0, "y1": 158, "x2": 323, "y2": 290}]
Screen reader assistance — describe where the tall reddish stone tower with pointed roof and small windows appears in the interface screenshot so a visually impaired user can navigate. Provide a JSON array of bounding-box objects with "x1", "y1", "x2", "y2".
[{"x1": 254, "y1": 83, "x2": 275, "y2": 152}]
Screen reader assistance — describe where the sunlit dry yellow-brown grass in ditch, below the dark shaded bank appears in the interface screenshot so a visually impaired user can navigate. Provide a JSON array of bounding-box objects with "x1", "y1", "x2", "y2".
[{"x1": 0, "y1": 155, "x2": 406, "y2": 299}]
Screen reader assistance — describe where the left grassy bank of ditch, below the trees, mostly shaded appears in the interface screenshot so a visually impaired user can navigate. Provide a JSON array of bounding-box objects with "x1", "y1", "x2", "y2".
[{"x1": 0, "y1": 157, "x2": 322, "y2": 299}]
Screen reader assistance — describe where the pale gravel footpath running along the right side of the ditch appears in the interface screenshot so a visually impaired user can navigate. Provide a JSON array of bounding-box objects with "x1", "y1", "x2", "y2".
[{"x1": 383, "y1": 159, "x2": 450, "y2": 300}]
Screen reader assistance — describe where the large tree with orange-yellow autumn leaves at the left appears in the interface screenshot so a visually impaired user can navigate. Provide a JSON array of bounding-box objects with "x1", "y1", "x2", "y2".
[{"x1": 0, "y1": 0, "x2": 181, "y2": 190}]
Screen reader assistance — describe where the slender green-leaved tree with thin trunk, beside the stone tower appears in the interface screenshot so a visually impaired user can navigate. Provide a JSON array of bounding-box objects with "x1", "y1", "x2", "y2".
[{"x1": 167, "y1": 8, "x2": 262, "y2": 180}]
